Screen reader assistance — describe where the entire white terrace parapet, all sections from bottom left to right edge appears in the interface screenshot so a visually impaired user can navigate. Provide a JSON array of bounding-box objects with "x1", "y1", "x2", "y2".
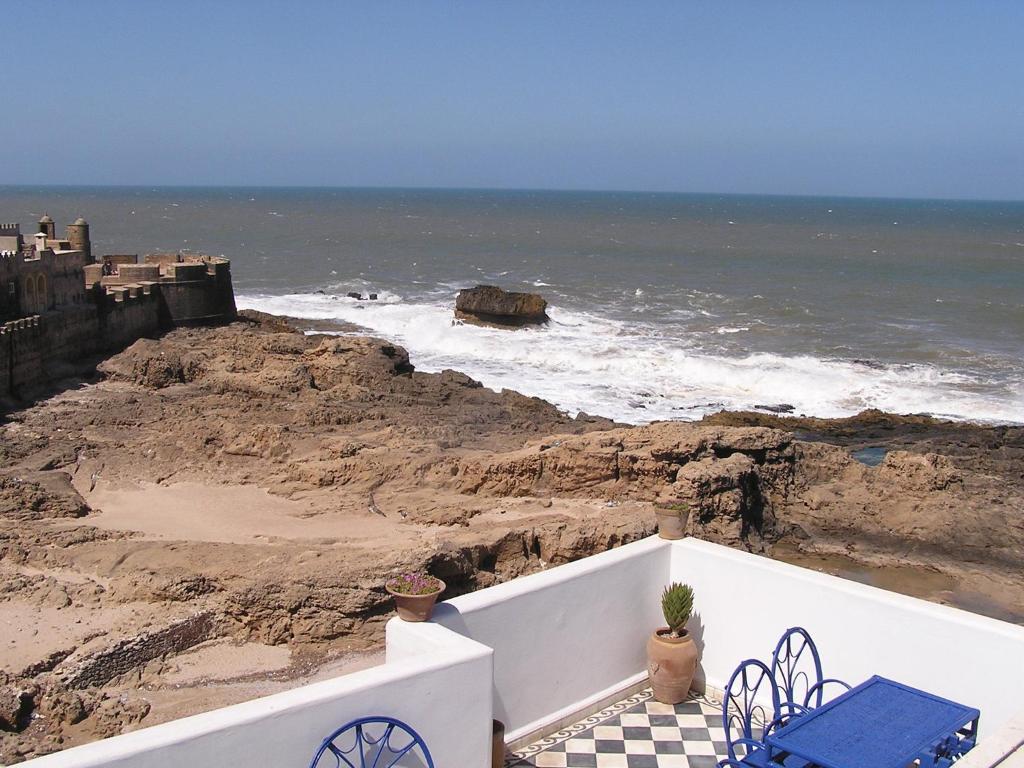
[{"x1": 16, "y1": 537, "x2": 1024, "y2": 768}]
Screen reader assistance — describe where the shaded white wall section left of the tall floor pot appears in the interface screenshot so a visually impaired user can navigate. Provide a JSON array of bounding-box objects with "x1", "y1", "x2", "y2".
[{"x1": 388, "y1": 537, "x2": 672, "y2": 741}]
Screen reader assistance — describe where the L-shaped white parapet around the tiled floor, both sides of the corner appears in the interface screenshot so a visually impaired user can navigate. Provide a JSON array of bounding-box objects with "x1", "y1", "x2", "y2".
[{"x1": 388, "y1": 538, "x2": 1024, "y2": 765}]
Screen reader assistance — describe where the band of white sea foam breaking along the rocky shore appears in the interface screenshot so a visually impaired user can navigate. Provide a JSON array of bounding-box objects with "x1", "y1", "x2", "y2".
[{"x1": 238, "y1": 291, "x2": 1024, "y2": 423}]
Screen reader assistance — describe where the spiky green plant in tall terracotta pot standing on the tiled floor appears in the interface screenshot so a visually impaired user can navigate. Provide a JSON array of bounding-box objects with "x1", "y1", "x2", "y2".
[{"x1": 647, "y1": 582, "x2": 697, "y2": 705}]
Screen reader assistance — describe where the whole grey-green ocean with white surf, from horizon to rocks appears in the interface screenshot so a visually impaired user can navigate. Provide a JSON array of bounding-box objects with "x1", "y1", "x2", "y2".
[{"x1": 0, "y1": 186, "x2": 1024, "y2": 423}]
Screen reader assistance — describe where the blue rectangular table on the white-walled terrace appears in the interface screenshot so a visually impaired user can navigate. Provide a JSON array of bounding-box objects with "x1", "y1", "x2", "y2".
[{"x1": 765, "y1": 676, "x2": 981, "y2": 768}]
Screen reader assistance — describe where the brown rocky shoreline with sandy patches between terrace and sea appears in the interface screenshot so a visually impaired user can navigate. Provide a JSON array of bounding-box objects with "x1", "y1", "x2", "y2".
[{"x1": 0, "y1": 312, "x2": 1024, "y2": 763}]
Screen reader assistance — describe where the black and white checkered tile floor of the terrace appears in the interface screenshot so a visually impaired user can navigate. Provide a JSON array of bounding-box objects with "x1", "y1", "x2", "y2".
[{"x1": 505, "y1": 688, "x2": 725, "y2": 768}]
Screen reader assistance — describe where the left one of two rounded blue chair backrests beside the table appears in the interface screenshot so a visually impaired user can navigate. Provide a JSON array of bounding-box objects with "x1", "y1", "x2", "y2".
[{"x1": 722, "y1": 658, "x2": 779, "y2": 762}]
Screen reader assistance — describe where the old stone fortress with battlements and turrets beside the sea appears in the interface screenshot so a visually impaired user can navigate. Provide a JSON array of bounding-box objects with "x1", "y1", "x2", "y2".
[{"x1": 0, "y1": 216, "x2": 234, "y2": 399}]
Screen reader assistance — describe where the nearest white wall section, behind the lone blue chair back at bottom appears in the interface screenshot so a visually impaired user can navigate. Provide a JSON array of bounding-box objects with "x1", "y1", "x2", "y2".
[{"x1": 23, "y1": 625, "x2": 492, "y2": 768}]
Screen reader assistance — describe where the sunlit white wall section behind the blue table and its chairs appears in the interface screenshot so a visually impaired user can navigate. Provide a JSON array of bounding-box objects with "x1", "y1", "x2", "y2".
[{"x1": 667, "y1": 539, "x2": 1024, "y2": 729}]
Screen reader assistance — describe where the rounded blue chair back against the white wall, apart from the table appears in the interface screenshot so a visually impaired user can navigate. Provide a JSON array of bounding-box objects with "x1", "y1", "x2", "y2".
[{"x1": 309, "y1": 717, "x2": 434, "y2": 768}]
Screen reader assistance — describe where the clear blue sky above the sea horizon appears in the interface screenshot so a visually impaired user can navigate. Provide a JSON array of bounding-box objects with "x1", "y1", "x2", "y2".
[{"x1": 0, "y1": 0, "x2": 1024, "y2": 200}]
